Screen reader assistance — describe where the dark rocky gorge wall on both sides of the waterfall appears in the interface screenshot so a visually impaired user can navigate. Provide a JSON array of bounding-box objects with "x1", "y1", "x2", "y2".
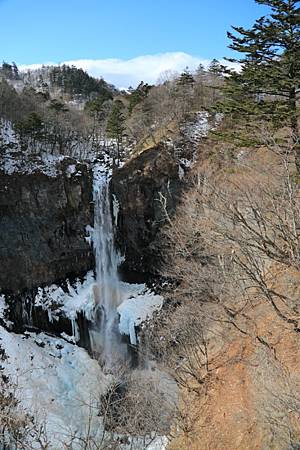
[{"x1": 0, "y1": 114, "x2": 208, "y2": 348}]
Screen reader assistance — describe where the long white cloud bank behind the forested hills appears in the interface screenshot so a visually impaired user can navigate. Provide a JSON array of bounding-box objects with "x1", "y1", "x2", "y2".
[{"x1": 19, "y1": 52, "x2": 239, "y2": 88}]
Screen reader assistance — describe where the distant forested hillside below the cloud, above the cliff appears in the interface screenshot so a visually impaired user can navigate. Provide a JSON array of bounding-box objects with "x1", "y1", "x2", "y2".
[{"x1": 0, "y1": 61, "x2": 222, "y2": 160}]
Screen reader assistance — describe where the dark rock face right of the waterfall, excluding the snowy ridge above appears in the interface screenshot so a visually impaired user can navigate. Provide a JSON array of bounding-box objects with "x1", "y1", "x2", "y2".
[{"x1": 112, "y1": 145, "x2": 183, "y2": 282}]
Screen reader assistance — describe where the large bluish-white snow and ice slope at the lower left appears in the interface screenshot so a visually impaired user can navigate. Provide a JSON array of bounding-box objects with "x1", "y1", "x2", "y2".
[{"x1": 0, "y1": 327, "x2": 110, "y2": 450}]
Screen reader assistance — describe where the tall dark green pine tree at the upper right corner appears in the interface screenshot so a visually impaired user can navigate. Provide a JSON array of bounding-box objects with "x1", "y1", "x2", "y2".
[{"x1": 223, "y1": 0, "x2": 300, "y2": 165}]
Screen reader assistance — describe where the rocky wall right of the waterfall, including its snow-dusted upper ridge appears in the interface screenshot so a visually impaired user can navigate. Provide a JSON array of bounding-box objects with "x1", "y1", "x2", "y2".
[{"x1": 111, "y1": 111, "x2": 213, "y2": 282}]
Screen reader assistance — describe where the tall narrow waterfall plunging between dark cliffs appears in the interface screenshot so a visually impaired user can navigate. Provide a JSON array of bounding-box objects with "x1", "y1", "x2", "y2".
[{"x1": 90, "y1": 172, "x2": 127, "y2": 369}]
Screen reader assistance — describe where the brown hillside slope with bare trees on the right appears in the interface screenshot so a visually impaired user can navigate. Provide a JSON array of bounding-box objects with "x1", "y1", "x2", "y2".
[{"x1": 157, "y1": 140, "x2": 300, "y2": 450}]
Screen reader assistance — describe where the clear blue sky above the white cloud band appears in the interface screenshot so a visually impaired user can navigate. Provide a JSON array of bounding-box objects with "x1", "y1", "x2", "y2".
[{"x1": 0, "y1": 0, "x2": 266, "y2": 86}]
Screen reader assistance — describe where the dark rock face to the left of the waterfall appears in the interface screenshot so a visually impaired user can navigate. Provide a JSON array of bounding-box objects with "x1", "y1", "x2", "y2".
[{"x1": 0, "y1": 162, "x2": 94, "y2": 296}]
